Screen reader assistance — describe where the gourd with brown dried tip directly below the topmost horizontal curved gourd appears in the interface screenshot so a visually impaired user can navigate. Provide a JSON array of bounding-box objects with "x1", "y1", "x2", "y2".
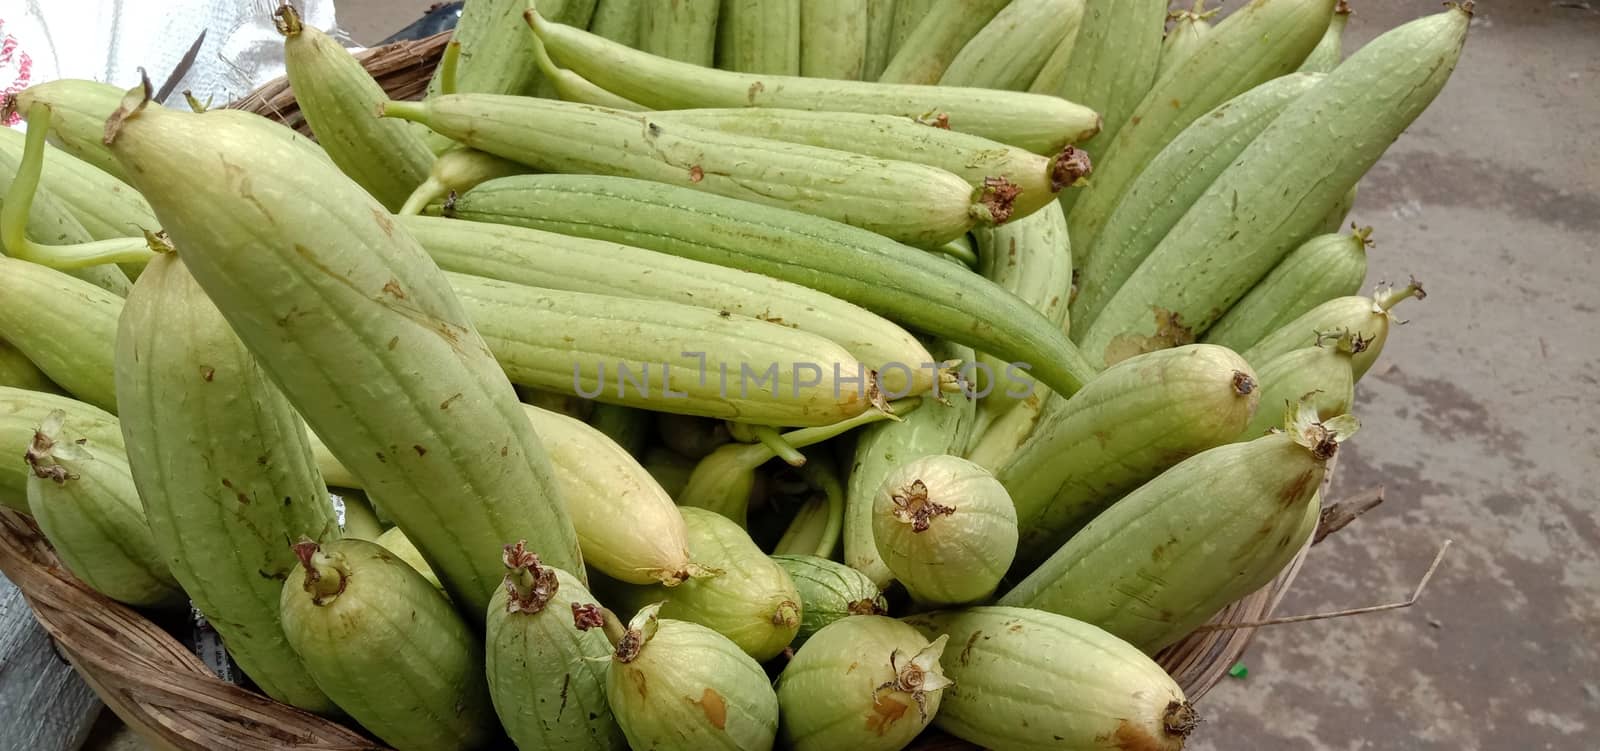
[{"x1": 653, "y1": 107, "x2": 1090, "y2": 222}]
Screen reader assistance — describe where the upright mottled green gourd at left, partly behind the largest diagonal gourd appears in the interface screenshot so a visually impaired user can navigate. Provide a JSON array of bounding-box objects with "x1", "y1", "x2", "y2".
[{"x1": 115, "y1": 253, "x2": 339, "y2": 713}]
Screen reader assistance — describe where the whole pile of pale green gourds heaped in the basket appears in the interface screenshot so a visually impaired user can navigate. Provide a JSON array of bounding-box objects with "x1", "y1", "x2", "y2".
[{"x1": 0, "y1": 0, "x2": 1472, "y2": 751}]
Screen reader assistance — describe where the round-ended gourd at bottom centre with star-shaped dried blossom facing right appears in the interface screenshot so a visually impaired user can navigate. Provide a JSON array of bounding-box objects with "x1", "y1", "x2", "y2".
[{"x1": 778, "y1": 615, "x2": 950, "y2": 751}]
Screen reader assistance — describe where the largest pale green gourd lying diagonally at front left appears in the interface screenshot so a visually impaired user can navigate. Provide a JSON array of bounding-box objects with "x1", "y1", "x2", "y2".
[{"x1": 112, "y1": 96, "x2": 581, "y2": 616}]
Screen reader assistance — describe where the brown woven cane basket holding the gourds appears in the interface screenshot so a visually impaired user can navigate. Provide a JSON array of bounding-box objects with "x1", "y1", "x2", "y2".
[{"x1": 0, "y1": 34, "x2": 1333, "y2": 751}]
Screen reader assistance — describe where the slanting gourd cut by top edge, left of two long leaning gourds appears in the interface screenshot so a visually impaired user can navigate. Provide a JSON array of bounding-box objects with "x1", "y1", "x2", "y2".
[{"x1": 1069, "y1": 0, "x2": 1334, "y2": 258}]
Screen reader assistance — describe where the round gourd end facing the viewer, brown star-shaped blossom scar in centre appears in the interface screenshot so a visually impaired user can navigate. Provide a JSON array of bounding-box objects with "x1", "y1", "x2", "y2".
[{"x1": 872, "y1": 456, "x2": 1018, "y2": 605}]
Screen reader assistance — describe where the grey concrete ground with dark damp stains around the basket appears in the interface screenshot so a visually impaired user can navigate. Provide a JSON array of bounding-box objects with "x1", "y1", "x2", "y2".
[{"x1": 338, "y1": 0, "x2": 1600, "y2": 751}]
